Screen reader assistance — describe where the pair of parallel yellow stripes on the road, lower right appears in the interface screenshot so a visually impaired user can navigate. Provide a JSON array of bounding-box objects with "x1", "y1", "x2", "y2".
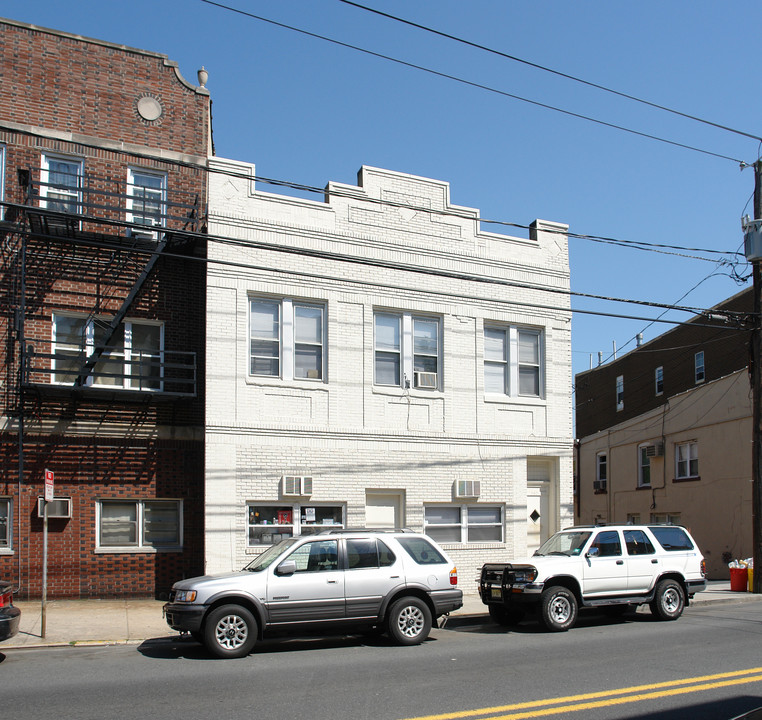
[{"x1": 398, "y1": 667, "x2": 762, "y2": 720}]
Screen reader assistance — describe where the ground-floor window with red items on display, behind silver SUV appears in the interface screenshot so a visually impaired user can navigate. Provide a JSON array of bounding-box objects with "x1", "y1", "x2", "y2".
[{"x1": 246, "y1": 502, "x2": 345, "y2": 547}]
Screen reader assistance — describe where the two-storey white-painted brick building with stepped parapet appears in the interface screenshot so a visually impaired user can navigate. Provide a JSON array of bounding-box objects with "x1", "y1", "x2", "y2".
[{"x1": 206, "y1": 159, "x2": 573, "y2": 592}]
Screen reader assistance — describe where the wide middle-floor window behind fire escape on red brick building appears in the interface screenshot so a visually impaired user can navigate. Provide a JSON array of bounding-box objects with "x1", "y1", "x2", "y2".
[{"x1": 52, "y1": 313, "x2": 164, "y2": 390}]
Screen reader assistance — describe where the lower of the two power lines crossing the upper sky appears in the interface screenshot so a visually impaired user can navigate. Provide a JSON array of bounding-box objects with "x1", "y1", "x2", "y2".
[{"x1": 201, "y1": 0, "x2": 748, "y2": 167}]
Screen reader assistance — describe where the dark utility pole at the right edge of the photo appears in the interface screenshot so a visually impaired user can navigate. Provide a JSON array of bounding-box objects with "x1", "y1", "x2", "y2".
[{"x1": 750, "y1": 160, "x2": 762, "y2": 593}]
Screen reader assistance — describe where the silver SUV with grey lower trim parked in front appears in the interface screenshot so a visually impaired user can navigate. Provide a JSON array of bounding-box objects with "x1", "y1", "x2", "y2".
[{"x1": 164, "y1": 530, "x2": 463, "y2": 658}]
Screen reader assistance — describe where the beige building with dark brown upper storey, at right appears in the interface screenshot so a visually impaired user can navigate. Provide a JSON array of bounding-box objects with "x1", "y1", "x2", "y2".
[{"x1": 575, "y1": 290, "x2": 752, "y2": 579}]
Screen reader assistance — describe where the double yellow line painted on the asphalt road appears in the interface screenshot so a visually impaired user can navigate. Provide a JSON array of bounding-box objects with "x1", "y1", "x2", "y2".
[{"x1": 407, "y1": 667, "x2": 762, "y2": 720}]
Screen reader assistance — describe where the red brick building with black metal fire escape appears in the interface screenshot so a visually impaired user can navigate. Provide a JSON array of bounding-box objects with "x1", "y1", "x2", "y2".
[{"x1": 0, "y1": 19, "x2": 211, "y2": 599}]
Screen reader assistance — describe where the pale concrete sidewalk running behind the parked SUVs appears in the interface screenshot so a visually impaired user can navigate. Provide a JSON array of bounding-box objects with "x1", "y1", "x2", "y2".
[{"x1": 0, "y1": 581, "x2": 762, "y2": 652}]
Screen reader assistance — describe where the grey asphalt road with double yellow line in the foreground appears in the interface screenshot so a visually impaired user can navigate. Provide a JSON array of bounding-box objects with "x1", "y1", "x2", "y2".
[{"x1": 0, "y1": 603, "x2": 762, "y2": 720}]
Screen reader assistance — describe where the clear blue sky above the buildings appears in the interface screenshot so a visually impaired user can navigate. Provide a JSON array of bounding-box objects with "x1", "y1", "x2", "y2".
[{"x1": 0, "y1": 0, "x2": 762, "y2": 400}]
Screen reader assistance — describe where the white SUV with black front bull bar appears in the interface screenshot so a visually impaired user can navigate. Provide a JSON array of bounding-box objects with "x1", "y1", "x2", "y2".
[{"x1": 479, "y1": 525, "x2": 706, "y2": 631}]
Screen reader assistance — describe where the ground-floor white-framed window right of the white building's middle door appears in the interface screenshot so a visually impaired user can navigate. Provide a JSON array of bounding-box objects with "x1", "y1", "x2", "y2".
[{"x1": 423, "y1": 505, "x2": 503, "y2": 543}]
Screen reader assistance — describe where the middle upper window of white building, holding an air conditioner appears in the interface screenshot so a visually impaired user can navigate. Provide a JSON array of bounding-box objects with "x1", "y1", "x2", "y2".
[{"x1": 373, "y1": 313, "x2": 441, "y2": 390}]
